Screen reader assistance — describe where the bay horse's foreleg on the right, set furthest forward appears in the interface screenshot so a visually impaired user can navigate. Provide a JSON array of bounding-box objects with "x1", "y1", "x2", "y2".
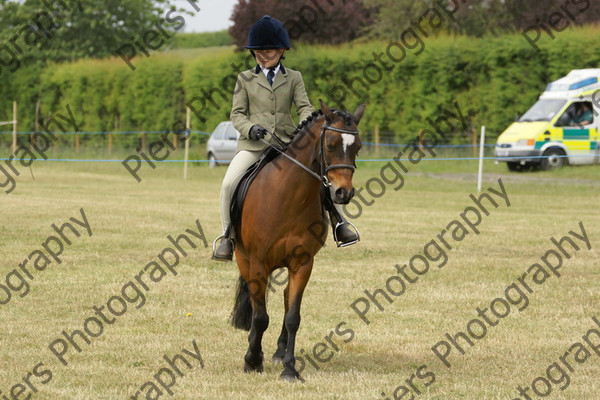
[{"x1": 281, "y1": 259, "x2": 313, "y2": 381}]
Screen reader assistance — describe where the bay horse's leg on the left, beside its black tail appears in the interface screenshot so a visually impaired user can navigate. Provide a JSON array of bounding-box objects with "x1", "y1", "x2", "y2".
[{"x1": 244, "y1": 262, "x2": 269, "y2": 372}]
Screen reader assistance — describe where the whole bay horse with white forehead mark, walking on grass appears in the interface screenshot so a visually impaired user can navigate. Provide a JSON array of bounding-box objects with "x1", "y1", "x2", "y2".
[{"x1": 231, "y1": 100, "x2": 365, "y2": 381}]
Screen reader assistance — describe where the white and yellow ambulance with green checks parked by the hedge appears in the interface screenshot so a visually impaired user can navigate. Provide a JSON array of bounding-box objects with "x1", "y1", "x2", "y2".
[{"x1": 494, "y1": 69, "x2": 600, "y2": 171}]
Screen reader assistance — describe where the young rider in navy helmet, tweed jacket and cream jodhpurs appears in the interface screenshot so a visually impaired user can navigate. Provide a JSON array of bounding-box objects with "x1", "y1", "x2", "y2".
[{"x1": 213, "y1": 15, "x2": 358, "y2": 261}]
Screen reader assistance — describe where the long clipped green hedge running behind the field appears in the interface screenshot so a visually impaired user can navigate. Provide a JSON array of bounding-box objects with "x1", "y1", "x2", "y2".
[{"x1": 0, "y1": 27, "x2": 600, "y2": 150}]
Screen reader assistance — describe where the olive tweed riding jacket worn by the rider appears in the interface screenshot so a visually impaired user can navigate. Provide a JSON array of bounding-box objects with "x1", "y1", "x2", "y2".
[{"x1": 230, "y1": 65, "x2": 315, "y2": 152}]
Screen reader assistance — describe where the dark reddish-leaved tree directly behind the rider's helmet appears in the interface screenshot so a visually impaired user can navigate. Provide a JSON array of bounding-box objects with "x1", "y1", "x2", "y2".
[{"x1": 229, "y1": 0, "x2": 372, "y2": 47}]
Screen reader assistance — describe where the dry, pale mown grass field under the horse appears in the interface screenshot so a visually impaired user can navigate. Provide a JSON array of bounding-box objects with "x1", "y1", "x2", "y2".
[{"x1": 0, "y1": 155, "x2": 600, "y2": 400}]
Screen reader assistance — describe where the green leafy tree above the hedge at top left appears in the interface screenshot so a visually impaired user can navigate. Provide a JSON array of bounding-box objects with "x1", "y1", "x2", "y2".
[{"x1": 0, "y1": 0, "x2": 192, "y2": 69}]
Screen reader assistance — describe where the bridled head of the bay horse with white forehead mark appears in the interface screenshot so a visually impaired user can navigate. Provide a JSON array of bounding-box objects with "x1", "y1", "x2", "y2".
[{"x1": 319, "y1": 100, "x2": 365, "y2": 204}]
